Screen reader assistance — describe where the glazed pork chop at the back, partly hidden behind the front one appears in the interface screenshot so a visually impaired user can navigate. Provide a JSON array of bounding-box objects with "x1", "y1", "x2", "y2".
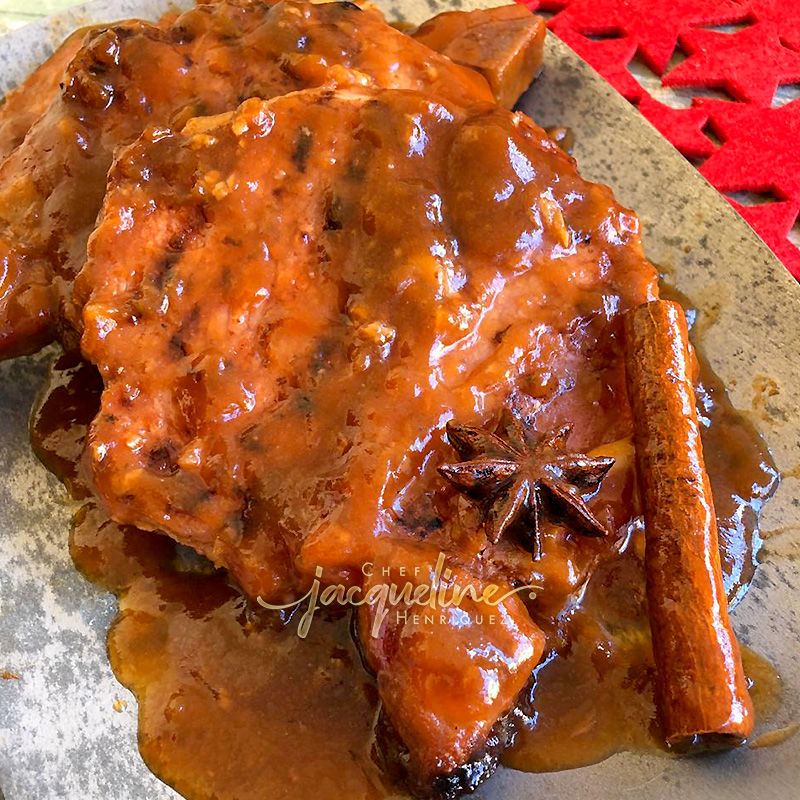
[{"x1": 0, "y1": 0, "x2": 541, "y2": 358}]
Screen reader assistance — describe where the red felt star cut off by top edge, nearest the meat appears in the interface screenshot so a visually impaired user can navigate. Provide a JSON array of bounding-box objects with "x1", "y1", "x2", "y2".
[{"x1": 548, "y1": 0, "x2": 748, "y2": 75}]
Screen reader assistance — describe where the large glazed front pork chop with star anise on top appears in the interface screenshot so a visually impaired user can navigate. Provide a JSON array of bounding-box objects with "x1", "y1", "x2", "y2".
[{"x1": 74, "y1": 87, "x2": 657, "y2": 794}]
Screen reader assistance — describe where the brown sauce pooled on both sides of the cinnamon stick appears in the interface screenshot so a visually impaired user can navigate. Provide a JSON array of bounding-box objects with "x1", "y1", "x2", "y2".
[{"x1": 503, "y1": 285, "x2": 782, "y2": 772}]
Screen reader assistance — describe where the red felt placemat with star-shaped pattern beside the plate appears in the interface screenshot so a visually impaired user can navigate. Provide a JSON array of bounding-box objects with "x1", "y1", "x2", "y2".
[{"x1": 519, "y1": 0, "x2": 800, "y2": 279}]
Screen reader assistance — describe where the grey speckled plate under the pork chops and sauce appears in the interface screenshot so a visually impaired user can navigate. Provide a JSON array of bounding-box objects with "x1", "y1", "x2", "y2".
[{"x1": 0, "y1": 0, "x2": 800, "y2": 800}]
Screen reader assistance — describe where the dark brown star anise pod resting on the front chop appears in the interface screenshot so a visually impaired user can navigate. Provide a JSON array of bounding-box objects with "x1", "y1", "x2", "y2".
[{"x1": 439, "y1": 413, "x2": 614, "y2": 559}]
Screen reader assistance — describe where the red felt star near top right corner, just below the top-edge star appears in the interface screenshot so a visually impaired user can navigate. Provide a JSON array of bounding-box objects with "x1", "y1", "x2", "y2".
[{"x1": 662, "y1": 24, "x2": 800, "y2": 106}]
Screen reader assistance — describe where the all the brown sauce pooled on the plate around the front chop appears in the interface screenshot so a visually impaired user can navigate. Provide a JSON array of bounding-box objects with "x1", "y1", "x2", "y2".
[{"x1": 32, "y1": 344, "x2": 780, "y2": 800}]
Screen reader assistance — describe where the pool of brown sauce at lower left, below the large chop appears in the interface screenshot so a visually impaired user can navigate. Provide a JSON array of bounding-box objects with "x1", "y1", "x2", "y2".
[{"x1": 72, "y1": 504, "x2": 388, "y2": 800}]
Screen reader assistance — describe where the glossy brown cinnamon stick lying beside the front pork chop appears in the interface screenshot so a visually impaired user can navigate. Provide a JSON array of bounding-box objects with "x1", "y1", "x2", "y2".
[{"x1": 624, "y1": 300, "x2": 753, "y2": 749}]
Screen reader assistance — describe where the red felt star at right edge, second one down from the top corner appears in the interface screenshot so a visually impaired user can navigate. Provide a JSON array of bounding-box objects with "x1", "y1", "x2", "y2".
[{"x1": 695, "y1": 99, "x2": 800, "y2": 200}]
